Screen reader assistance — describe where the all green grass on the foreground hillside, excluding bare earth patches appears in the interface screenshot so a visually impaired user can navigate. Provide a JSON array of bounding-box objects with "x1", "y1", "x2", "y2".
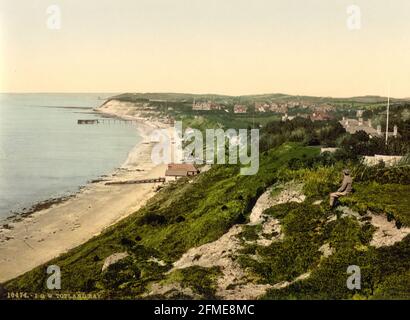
[{"x1": 7, "y1": 144, "x2": 410, "y2": 299}]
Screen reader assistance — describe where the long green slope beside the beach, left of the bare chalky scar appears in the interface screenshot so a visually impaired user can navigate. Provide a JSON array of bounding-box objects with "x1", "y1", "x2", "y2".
[{"x1": 7, "y1": 144, "x2": 318, "y2": 297}]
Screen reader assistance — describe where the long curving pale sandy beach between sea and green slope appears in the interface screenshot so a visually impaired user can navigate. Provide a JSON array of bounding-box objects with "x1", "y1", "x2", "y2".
[{"x1": 0, "y1": 102, "x2": 170, "y2": 282}]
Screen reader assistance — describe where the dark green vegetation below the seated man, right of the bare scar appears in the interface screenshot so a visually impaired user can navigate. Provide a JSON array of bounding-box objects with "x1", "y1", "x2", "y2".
[{"x1": 234, "y1": 178, "x2": 410, "y2": 299}]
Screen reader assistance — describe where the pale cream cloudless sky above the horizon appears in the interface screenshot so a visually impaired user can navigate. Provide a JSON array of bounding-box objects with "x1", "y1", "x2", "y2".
[{"x1": 0, "y1": 0, "x2": 410, "y2": 98}]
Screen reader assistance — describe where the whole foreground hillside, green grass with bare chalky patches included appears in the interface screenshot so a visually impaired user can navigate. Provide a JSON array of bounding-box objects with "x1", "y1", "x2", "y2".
[{"x1": 6, "y1": 132, "x2": 410, "y2": 299}]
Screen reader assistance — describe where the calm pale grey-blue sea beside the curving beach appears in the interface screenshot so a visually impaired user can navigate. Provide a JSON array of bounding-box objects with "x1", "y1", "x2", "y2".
[{"x1": 0, "y1": 94, "x2": 141, "y2": 219}]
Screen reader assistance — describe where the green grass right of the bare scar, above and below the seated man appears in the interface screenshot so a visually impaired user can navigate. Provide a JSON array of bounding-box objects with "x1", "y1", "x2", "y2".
[{"x1": 260, "y1": 166, "x2": 410, "y2": 299}]
